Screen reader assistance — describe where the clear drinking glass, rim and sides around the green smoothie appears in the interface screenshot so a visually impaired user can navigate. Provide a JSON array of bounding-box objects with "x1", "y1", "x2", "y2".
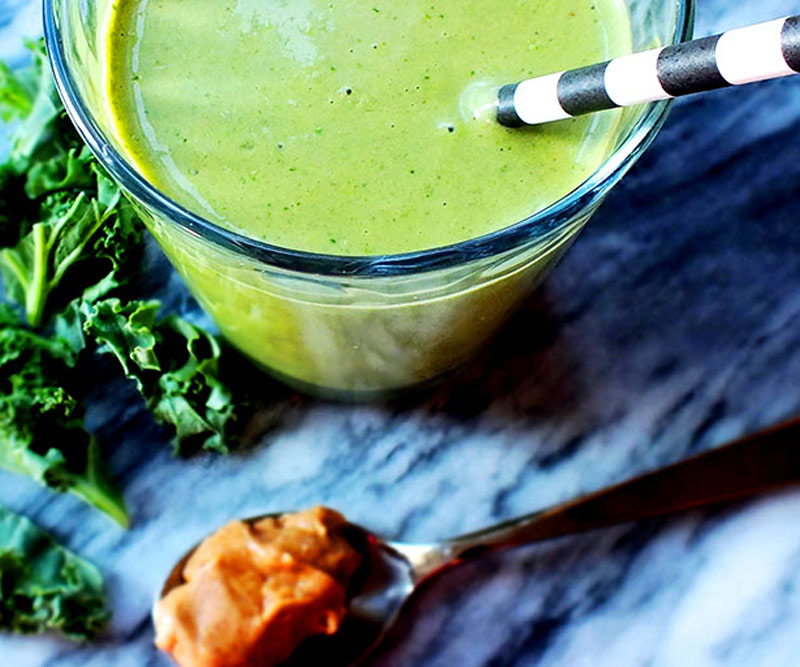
[{"x1": 44, "y1": 0, "x2": 694, "y2": 398}]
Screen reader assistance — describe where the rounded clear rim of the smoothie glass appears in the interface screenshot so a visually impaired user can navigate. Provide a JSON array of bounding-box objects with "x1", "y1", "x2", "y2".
[{"x1": 43, "y1": 0, "x2": 696, "y2": 277}]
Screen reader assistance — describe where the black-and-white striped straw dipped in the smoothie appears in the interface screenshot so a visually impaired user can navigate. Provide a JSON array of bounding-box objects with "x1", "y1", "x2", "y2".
[{"x1": 497, "y1": 16, "x2": 800, "y2": 127}]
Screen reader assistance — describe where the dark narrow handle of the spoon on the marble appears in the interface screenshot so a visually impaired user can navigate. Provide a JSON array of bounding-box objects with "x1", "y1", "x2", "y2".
[{"x1": 445, "y1": 418, "x2": 800, "y2": 561}]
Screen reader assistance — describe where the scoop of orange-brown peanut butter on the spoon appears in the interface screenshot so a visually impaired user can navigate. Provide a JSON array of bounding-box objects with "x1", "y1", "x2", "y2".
[{"x1": 155, "y1": 507, "x2": 361, "y2": 667}]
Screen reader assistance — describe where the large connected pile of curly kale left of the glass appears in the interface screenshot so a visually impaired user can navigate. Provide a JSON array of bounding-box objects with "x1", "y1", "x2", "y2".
[{"x1": 0, "y1": 42, "x2": 242, "y2": 523}]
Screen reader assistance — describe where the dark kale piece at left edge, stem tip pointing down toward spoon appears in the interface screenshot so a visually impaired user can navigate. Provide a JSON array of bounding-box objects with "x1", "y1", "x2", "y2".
[{"x1": 0, "y1": 304, "x2": 128, "y2": 525}]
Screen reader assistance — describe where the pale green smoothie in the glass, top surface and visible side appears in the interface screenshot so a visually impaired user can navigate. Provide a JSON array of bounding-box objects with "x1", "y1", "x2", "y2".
[{"x1": 103, "y1": 0, "x2": 632, "y2": 396}]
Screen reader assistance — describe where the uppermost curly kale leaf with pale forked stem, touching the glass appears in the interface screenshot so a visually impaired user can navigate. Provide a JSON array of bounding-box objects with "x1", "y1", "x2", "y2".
[{"x1": 0, "y1": 43, "x2": 141, "y2": 328}]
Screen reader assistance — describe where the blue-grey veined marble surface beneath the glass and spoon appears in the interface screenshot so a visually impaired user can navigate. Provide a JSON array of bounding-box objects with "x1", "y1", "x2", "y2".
[{"x1": 0, "y1": 0, "x2": 800, "y2": 667}]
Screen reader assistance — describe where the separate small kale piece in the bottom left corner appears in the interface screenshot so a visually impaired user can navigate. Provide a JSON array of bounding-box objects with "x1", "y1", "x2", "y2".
[{"x1": 0, "y1": 507, "x2": 111, "y2": 641}]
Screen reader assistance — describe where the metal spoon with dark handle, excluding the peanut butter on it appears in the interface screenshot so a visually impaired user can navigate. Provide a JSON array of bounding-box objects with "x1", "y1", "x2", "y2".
[{"x1": 158, "y1": 418, "x2": 800, "y2": 667}]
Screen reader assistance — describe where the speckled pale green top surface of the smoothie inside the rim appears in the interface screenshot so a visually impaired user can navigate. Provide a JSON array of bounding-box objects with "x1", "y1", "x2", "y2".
[{"x1": 107, "y1": 0, "x2": 631, "y2": 255}]
